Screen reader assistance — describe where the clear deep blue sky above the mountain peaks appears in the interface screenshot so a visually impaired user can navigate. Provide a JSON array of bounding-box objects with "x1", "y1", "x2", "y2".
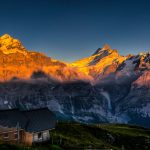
[{"x1": 0, "y1": 0, "x2": 150, "y2": 61}]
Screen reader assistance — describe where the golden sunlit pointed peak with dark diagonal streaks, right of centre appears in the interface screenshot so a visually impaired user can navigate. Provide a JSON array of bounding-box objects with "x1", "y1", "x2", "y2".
[{"x1": 71, "y1": 44, "x2": 127, "y2": 79}]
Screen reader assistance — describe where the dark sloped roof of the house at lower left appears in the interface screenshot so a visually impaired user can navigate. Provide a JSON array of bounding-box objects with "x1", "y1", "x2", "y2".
[{"x1": 0, "y1": 108, "x2": 56, "y2": 132}]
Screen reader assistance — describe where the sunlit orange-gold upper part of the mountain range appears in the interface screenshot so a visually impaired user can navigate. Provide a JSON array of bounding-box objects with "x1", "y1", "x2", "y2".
[{"x1": 0, "y1": 34, "x2": 150, "y2": 82}]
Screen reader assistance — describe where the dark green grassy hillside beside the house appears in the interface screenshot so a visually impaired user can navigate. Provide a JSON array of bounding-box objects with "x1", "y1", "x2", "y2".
[{"x1": 0, "y1": 122, "x2": 150, "y2": 150}]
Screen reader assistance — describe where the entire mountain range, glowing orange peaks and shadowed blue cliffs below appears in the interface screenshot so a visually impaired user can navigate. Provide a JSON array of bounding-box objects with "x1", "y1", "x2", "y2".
[{"x1": 0, "y1": 35, "x2": 150, "y2": 127}]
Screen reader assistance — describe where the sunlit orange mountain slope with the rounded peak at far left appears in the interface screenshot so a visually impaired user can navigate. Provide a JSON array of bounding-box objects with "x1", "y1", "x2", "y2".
[{"x1": 0, "y1": 34, "x2": 89, "y2": 81}]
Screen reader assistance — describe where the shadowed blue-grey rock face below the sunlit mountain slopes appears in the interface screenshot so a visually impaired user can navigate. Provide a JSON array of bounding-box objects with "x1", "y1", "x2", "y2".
[{"x1": 0, "y1": 71, "x2": 150, "y2": 127}]
